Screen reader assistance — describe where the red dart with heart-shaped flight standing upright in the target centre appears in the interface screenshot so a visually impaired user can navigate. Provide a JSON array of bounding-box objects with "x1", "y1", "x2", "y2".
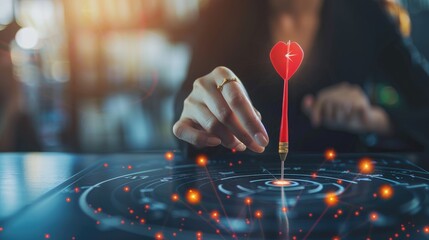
[{"x1": 270, "y1": 41, "x2": 304, "y2": 179}]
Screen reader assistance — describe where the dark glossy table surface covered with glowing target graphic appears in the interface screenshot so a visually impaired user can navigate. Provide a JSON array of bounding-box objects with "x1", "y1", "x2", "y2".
[{"x1": 0, "y1": 152, "x2": 429, "y2": 240}]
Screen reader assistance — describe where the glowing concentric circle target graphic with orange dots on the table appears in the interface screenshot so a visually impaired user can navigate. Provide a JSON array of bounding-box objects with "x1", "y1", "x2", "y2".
[{"x1": 79, "y1": 155, "x2": 428, "y2": 239}]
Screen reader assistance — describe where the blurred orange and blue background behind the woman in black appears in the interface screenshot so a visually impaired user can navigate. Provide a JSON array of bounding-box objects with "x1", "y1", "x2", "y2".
[{"x1": 0, "y1": 0, "x2": 429, "y2": 152}]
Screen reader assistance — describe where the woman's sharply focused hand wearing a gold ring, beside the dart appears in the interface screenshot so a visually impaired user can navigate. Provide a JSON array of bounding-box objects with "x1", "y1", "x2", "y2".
[{"x1": 173, "y1": 67, "x2": 268, "y2": 153}]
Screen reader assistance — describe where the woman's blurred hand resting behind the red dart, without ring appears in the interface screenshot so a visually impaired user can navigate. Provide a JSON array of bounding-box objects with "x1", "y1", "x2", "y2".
[{"x1": 302, "y1": 83, "x2": 392, "y2": 135}]
